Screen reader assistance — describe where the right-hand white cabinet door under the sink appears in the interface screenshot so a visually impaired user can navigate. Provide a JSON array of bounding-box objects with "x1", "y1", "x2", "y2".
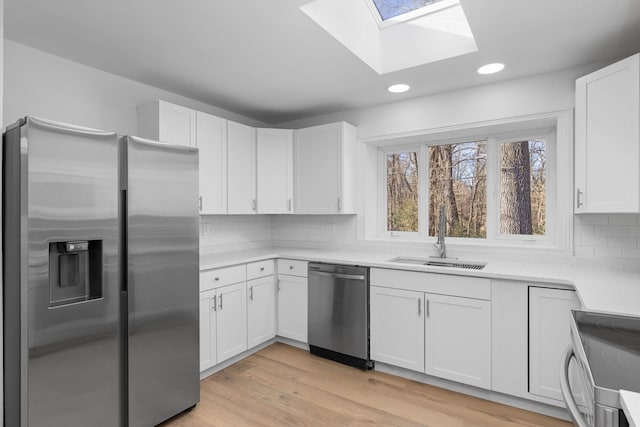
[{"x1": 425, "y1": 294, "x2": 491, "y2": 389}]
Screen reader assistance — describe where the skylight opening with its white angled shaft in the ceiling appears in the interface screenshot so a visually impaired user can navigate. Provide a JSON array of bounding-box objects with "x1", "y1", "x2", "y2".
[{"x1": 300, "y1": 0, "x2": 478, "y2": 74}]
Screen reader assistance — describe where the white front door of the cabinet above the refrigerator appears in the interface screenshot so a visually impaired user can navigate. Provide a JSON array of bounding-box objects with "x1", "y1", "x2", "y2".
[{"x1": 158, "y1": 101, "x2": 196, "y2": 147}]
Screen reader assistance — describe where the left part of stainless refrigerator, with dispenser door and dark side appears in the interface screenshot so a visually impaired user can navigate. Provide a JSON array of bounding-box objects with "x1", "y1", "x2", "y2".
[{"x1": 3, "y1": 117, "x2": 119, "y2": 427}]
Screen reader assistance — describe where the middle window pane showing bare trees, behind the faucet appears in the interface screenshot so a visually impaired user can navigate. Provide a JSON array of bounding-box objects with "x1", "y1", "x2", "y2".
[{"x1": 429, "y1": 141, "x2": 487, "y2": 238}]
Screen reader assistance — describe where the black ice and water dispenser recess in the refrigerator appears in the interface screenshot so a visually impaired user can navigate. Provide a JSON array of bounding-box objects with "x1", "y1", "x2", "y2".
[{"x1": 49, "y1": 240, "x2": 102, "y2": 307}]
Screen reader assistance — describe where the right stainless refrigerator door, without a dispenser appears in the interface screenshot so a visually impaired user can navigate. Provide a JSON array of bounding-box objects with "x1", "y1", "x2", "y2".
[{"x1": 123, "y1": 137, "x2": 200, "y2": 427}]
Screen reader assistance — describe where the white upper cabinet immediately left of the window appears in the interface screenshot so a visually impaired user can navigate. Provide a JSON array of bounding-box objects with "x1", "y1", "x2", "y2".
[{"x1": 294, "y1": 122, "x2": 357, "y2": 214}]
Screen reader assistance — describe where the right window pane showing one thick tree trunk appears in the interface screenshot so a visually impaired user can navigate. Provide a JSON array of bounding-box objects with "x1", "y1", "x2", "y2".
[{"x1": 500, "y1": 140, "x2": 546, "y2": 235}]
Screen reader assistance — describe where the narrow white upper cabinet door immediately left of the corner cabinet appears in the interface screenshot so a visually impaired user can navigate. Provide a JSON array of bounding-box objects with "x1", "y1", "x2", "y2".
[{"x1": 227, "y1": 121, "x2": 256, "y2": 214}]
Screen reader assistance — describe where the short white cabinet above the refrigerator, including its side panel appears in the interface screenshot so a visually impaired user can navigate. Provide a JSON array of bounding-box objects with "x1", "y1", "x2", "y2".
[{"x1": 137, "y1": 100, "x2": 196, "y2": 147}]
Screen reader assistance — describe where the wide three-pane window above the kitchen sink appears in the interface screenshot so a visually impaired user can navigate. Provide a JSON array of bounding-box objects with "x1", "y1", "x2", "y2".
[{"x1": 384, "y1": 132, "x2": 554, "y2": 247}]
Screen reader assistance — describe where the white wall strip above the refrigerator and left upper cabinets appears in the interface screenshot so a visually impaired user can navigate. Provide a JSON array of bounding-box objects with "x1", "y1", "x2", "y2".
[{"x1": 3, "y1": 39, "x2": 264, "y2": 135}]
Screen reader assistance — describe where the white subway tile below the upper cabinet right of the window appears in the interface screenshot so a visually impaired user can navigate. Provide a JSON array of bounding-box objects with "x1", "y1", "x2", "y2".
[{"x1": 574, "y1": 214, "x2": 640, "y2": 259}]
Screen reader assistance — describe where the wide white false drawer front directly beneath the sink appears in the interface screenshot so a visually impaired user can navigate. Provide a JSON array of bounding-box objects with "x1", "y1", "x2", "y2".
[{"x1": 370, "y1": 268, "x2": 491, "y2": 300}]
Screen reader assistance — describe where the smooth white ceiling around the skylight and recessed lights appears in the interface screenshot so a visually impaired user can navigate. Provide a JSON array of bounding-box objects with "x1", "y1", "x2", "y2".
[{"x1": 4, "y1": 0, "x2": 640, "y2": 123}]
